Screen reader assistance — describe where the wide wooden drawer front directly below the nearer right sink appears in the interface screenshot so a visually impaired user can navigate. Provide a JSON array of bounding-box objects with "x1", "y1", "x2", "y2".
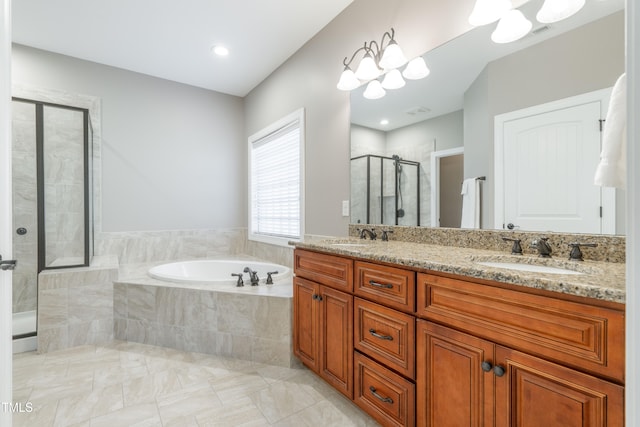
[{"x1": 417, "y1": 274, "x2": 624, "y2": 383}]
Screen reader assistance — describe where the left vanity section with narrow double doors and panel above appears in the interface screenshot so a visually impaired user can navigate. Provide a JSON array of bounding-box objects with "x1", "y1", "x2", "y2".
[{"x1": 293, "y1": 250, "x2": 353, "y2": 399}]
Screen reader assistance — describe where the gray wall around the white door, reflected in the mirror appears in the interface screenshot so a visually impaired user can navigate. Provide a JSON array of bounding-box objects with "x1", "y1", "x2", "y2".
[{"x1": 464, "y1": 12, "x2": 625, "y2": 232}]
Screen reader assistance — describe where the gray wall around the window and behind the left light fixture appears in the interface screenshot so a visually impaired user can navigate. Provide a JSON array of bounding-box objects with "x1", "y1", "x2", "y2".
[{"x1": 245, "y1": 0, "x2": 474, "y2": 235}]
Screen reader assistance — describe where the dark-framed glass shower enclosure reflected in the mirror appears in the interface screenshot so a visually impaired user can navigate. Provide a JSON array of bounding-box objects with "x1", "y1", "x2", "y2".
[{"x1": 351, "y1": 154, "x2": 420, "y2": 226}]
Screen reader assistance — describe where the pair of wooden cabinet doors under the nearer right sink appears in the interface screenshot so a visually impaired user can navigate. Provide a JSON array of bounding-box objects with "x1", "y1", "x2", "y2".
[{"x1": 416, "y1": 320, "x2": 624, "y2": 427}]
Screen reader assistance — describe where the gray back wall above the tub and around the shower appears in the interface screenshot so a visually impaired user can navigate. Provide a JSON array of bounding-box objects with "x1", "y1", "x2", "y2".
[{"x1": 12, "y1": 45, "x2": 247, "y2": 231}]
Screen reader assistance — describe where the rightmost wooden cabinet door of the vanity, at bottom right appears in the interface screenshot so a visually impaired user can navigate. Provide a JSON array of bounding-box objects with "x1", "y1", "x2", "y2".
[{"x1": 496, "y1": 346, "x2": 624, "y2": 427}]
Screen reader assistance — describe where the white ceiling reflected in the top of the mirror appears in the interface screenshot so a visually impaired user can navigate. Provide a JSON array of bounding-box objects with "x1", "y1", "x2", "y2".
[{"x1": 350, "y1": 0, "x2": 624, "y2": 131}]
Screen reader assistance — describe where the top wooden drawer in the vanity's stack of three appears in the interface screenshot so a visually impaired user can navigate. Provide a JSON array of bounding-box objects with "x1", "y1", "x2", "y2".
[{"x1": 354, "y1": 261, "x2": 416, "y2": 313}]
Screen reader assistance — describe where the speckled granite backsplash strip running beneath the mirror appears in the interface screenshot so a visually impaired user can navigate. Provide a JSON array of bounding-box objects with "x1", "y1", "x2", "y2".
[{"x1": 349, "y1": 224, "x2": 626, "y2": 263}]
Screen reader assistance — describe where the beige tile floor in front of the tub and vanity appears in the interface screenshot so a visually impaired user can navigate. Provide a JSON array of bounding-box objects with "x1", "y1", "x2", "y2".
[{"x1": 13, "y1": 341, "x2": 377, "y2": 427}]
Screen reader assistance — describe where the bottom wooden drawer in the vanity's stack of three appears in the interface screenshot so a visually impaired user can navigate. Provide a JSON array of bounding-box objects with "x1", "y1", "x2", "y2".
[{"x1": 353, "y1": 352, "x2": 416, "y2": 426}]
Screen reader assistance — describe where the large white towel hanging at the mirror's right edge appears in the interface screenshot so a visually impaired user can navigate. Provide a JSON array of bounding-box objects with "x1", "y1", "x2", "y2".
[{"x1": 594, "y1": 74, "x2": 627, "y2": 188}]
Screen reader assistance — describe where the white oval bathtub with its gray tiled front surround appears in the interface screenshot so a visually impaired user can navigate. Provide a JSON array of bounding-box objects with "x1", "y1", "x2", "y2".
[{"x1": 113, "y1": 259, "x2": 295, "y2": 367}]
